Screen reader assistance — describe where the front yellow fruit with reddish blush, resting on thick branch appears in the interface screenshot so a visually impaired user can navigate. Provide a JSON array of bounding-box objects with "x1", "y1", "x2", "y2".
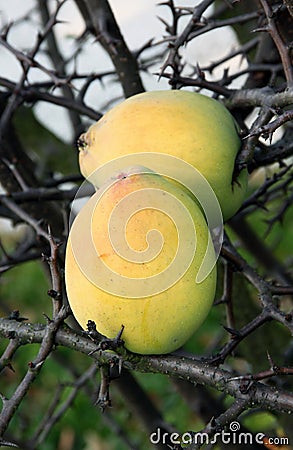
[{"x1": 65, "y1": 173, "x2": 216, "y2": 354}]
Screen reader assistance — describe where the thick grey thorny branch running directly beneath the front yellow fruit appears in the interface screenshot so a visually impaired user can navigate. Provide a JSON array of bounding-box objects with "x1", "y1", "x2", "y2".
[{"x1": 0, "y1": 319, "x2": 293, "y2": 412}]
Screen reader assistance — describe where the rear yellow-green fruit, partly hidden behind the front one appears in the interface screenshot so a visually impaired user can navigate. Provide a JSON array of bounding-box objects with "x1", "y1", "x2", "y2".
[{"x1": 79, "y1": 90, "x2": 247, "y2": 220}]
